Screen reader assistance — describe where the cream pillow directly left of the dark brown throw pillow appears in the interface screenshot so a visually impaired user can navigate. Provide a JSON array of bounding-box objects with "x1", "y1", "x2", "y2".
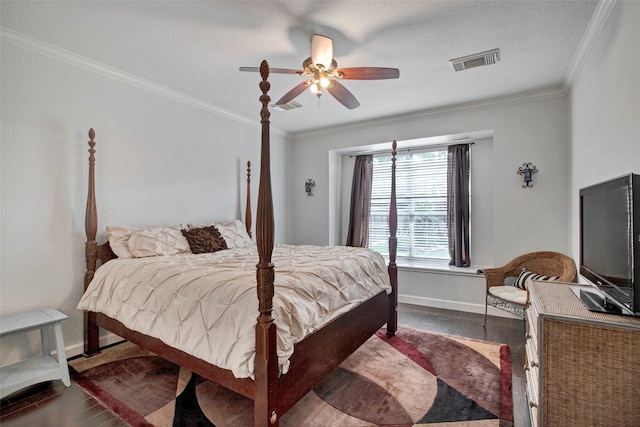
[{"x1": 127, "y1": 227, "x2": 191, "y2": 258}]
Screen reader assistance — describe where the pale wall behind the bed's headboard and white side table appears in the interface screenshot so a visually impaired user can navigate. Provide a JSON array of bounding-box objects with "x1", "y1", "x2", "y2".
[{"x1": 0, "y1": 43, "x2": 287, "y2": 365}]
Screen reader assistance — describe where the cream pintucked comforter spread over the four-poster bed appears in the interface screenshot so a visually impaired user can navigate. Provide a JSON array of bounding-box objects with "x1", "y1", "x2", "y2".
[{"x1": 78, "y1": 245, "x2": 391, "y2": 378}]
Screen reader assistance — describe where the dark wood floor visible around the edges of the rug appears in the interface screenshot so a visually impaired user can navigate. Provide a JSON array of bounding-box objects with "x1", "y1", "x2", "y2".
[{"x1": 0, "y1": 304, "x2": 531, "y2": 427}]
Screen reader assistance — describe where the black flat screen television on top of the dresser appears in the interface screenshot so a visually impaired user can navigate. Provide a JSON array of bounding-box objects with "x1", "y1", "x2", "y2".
[{"x1": 579, "y1": 174, "x2": 640, "y2": 316}]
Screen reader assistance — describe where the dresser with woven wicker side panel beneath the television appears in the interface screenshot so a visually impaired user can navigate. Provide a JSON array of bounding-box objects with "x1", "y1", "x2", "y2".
[{"x1": 525, "y1": 282, "x2": 640, "y2": 427}]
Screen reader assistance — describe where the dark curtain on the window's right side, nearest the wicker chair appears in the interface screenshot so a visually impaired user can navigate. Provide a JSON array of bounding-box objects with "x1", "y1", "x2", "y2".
[{"x1": 447, "y1": 144, "x2": 471, "y2": 267}]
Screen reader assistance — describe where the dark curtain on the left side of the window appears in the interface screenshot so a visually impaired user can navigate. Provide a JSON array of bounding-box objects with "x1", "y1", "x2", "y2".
[{"x1": 346, "y1": 154, "x2": 373, "y2": 248}]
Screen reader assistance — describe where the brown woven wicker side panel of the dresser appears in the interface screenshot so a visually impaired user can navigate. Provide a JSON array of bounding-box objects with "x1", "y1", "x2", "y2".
[{"x1": 543, "y1": 319, "x2": 640, "y2": 427}]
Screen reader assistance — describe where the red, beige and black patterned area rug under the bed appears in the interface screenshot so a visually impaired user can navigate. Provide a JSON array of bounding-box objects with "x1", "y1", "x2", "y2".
[{"x1": 70, "y1": 327, "x2": 513, "y2": 427}]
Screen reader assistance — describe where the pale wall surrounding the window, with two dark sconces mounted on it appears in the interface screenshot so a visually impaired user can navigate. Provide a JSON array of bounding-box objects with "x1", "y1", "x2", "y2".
[{"x1": 292, "y1": 95, "x2": 567, "y2": 264}]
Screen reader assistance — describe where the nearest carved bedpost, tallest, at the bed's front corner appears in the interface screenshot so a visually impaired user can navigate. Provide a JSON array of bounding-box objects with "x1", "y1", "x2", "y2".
[{"x1": 254, "y1": 61, "x2": 280, "y2": 427}]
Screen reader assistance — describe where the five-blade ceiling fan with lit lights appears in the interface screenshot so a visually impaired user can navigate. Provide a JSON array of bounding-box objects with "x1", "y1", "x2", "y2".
[{"x1": 240, "y1": 34, "x2": 400, "y2": 110}]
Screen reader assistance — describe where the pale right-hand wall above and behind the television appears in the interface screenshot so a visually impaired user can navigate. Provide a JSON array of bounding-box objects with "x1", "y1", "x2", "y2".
[{"x1": 569, "y1": 1, "x2": 640, "y2": 268}]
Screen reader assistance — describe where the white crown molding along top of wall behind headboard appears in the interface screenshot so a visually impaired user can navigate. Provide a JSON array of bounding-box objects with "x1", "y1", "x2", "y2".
[{"x1": 0, "y1": 27, "x2": 287, "y2": 136}]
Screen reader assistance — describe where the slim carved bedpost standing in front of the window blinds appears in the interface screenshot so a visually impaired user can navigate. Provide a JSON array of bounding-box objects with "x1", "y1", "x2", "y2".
[{"x1": 387, "y1": 140, "x2": 398, "y2": 335}]
